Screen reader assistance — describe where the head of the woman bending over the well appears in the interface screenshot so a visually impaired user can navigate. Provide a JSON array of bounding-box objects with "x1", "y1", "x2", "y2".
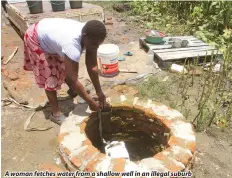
[{"x1": 82, "y1": 20, "x2": 106, "y2": 50}]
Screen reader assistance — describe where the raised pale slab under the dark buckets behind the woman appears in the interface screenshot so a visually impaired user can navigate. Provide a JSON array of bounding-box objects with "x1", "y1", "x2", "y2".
[{"x1": 6, "y1": 1, "x2": 104, "y2": 34}]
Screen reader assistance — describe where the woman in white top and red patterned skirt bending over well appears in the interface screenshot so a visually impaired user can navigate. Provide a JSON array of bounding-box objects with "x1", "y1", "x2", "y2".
[{"x1": 24, "y1": 18, "x2": 106, "y2": 125}]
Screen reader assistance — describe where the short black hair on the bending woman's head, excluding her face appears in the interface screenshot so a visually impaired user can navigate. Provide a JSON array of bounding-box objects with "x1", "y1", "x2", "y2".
[{"x1": 82, "y1": 20, "x2": 106, "y2": 40}]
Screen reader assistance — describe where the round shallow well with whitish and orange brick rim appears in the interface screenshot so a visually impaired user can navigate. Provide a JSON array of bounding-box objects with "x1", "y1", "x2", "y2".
[{"x1": 59, "y1": 95, "x2": 195, "y2": 176}]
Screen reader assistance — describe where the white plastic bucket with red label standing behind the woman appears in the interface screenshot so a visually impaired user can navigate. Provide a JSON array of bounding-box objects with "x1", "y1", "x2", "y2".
[{"x1": 97, "y1": 44, "x2": 119, "y2": 77}]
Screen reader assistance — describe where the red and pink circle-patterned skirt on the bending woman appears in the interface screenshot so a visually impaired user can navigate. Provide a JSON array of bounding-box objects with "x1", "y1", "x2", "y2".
[{"x1": 24, "y1": 23, "x2": 65, "y2": 91}]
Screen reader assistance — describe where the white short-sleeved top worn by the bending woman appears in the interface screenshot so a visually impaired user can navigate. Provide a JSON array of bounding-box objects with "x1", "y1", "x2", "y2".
[{"x1": 37, "y1": 18, "x2": 85, "y2": 62}]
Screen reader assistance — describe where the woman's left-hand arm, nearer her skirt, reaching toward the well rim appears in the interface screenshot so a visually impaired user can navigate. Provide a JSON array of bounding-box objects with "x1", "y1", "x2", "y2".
[{"x1": 64, "y1": 56, "x2": 98, "y2": 110}]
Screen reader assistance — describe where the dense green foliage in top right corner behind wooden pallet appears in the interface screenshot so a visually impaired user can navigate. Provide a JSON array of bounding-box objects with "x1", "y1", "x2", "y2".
[{"x1": 130, "y1": 1, "x2": 232, "y2": 52}]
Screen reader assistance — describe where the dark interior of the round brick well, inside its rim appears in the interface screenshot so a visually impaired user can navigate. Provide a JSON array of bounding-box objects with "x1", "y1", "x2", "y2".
[{"x1": 85, "y1": 108, "x2": 170, "y2": 161}]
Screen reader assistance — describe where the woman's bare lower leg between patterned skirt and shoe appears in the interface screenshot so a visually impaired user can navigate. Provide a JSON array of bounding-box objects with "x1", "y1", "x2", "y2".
[{"x1": 45, "y1": 90, "x2": 62, "y2": 116}]
